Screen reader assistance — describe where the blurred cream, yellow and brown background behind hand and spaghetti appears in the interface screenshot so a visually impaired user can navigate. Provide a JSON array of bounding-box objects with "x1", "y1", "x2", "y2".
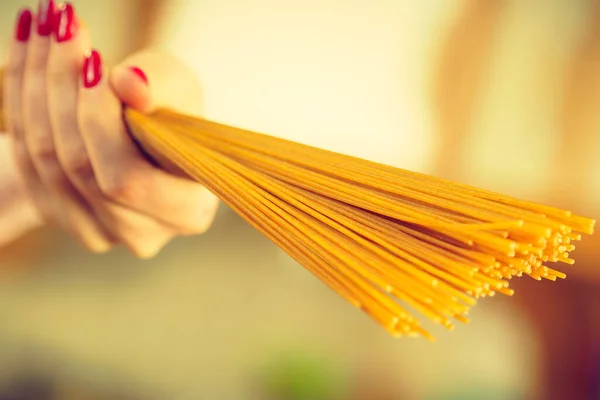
[{"x1": 0, "y1": 0, "x2": 600, "y2": 400}]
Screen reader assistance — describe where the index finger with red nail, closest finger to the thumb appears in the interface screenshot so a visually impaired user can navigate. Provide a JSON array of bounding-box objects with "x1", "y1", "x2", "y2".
[{"x1": 78, "y1": 53, "x2": 218, "y2": 234}]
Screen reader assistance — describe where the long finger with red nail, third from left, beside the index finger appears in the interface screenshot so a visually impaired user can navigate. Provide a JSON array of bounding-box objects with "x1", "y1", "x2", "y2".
[{"x1": 44, "y1": 4, "x2": 173, "y2": 258}]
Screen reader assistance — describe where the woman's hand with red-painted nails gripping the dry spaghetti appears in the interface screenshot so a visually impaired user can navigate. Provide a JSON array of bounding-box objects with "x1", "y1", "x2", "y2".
[{"x1": 4, "y1": 0, "x2": 218, "y2": 258}]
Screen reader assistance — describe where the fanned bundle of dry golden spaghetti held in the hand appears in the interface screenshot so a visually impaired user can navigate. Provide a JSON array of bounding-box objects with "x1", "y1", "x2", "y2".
[{"x1": 125, "y1": 109, "x2": 594, "y2": 339}]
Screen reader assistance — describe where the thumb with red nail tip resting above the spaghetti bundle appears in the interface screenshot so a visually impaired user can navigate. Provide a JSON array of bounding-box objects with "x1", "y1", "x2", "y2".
[{"x1": 110, "y1": 51, "x2": 202, "y2": 115}]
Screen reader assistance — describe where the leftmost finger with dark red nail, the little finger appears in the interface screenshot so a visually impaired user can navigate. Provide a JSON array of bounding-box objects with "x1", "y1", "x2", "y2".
[{"x1": 3, "y1": 8, "x2": 54, "y2": 222}]
